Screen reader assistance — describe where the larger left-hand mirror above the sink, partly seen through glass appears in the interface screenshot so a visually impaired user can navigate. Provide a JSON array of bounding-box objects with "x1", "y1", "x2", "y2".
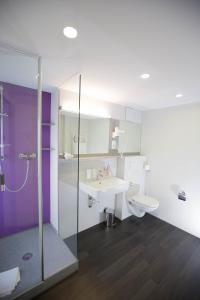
[{"x1": 59, "y1": 111, "x2": 110, "y2": 158}]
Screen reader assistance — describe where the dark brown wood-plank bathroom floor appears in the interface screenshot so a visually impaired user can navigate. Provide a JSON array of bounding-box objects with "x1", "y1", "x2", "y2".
[{"x1": 36, "y1": 215, "x2": 200, "y2": 300}]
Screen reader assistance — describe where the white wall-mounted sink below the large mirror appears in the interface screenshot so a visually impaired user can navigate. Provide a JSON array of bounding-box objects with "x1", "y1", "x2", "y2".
[{"x1": 79, "y1": 177, "x2": 129, "y2": 199}]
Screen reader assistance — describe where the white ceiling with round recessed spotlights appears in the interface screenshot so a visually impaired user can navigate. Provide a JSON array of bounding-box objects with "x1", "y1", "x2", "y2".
[{"x1": 0, "y1": 0, "x2": 200, "y2": 109}]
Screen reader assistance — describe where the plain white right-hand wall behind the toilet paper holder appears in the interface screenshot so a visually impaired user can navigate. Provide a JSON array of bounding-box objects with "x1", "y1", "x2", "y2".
[{"x1": 142, "y1": 104, "x2": 200, "y2": 237}]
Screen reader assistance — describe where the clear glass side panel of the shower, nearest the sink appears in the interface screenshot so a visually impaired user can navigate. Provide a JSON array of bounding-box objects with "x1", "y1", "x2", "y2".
[{"x1": 58, "y1": 75, "x2": 81, "y2": 270}]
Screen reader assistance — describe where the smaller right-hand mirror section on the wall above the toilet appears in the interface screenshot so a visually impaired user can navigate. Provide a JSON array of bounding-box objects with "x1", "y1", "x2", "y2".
[{"x1": 118, "y1": 121, "x2": 141, "y2": 153}]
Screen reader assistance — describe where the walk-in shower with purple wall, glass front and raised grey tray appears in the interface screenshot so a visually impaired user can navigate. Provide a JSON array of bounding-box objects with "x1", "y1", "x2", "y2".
[{"x1": 0, "y1": 44, "x2": 80, "y2": 299}]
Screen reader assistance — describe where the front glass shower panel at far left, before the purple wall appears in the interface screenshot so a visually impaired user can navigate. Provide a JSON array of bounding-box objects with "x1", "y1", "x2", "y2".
[{"x1": 0, "y1": 46, "x2": 42, "y2": 299}]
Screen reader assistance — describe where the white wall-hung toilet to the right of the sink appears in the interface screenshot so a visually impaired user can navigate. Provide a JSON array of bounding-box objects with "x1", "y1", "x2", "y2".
[{"x1": 126, "y1": 183, "x2": 159, "y2": 218}]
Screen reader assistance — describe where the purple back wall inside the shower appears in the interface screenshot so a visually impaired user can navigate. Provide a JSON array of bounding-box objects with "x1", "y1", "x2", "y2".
[{"x1": 0, "y1": 83, "x2": 51, "y2": 236}]
